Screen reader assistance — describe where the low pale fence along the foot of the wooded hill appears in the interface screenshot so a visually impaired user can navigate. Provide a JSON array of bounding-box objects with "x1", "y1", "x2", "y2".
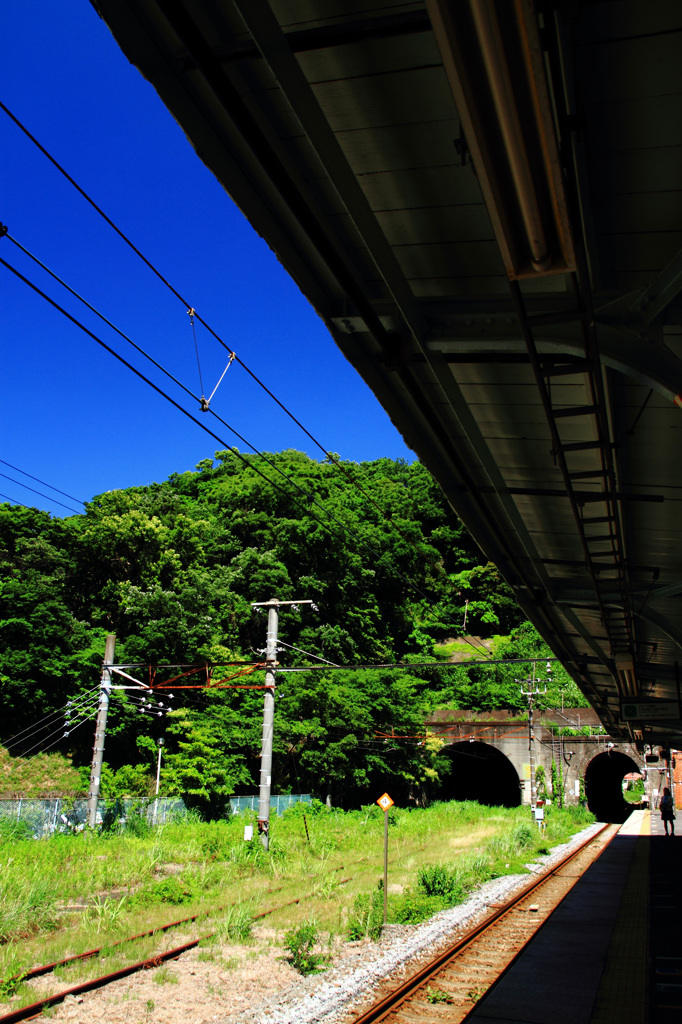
[{"x1": 0, "y1": 794, "x2": 311, "y2": 839}]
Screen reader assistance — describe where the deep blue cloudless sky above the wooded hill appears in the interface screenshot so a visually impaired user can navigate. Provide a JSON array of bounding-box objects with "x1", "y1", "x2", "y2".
[{"x1": 0, "y1": 0, "x2": 414, "y2": 515}]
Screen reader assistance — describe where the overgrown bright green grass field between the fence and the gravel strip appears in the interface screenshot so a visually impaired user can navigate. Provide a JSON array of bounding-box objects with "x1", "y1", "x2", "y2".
[{"x1": 0, "y1": 802, "x2": 593, "y2": 1001}]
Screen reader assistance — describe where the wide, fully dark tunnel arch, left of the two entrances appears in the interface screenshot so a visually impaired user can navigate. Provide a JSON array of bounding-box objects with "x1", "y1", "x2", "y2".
[{"x1": 440, "y1": 740, "x2": 521, "y2": 807}]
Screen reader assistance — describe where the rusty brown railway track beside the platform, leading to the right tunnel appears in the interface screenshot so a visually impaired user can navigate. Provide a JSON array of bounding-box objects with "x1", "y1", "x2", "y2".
[{"x1": 345, "y1": 825, "x2": 619, "y2": 1024}]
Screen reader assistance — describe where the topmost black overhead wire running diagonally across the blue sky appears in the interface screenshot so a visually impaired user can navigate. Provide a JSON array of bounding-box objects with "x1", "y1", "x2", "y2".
[{"x1": 0, "y1": 101, "x2": 489, "y2": 659}]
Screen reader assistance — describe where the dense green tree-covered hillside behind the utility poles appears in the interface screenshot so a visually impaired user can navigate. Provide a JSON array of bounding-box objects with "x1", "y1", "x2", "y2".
[{"x1": 0, "y1": 450, "x2": 585, "y2": 807}]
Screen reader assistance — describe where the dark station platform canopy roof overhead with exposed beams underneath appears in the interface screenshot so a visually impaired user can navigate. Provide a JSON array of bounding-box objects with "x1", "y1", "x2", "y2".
[{"x1": 92, "y1": 0, "x2": 682, "y2": 750}]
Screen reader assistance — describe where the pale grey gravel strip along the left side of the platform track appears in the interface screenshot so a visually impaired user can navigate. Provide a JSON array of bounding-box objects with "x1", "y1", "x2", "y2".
[{"x1": 233, "y1": 824, "x2": 602, "y2": 1024}]
